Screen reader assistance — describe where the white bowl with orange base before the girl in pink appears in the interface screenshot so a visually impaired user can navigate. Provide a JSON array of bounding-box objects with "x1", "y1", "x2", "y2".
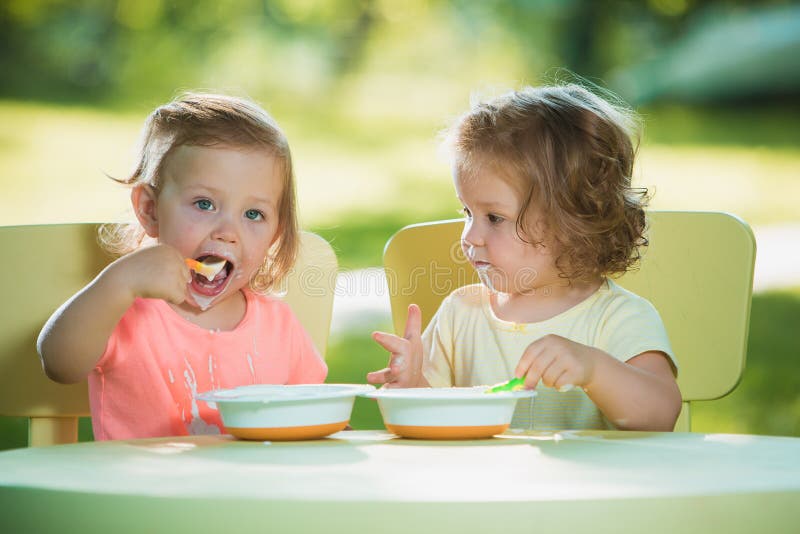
[{"x1": 196, "y1": 384, "x2": 375, "y2": 441}]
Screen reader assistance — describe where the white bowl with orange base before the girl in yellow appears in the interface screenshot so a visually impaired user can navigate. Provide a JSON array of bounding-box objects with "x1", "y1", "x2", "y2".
[{"x1": 361, "y1": 386, "x2": 536, "y2": 439}]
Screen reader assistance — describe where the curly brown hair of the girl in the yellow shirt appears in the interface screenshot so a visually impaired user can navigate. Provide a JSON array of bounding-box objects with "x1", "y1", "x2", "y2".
[{"x1": 447, "y1": 84, "x2": 648, "y2": 280}]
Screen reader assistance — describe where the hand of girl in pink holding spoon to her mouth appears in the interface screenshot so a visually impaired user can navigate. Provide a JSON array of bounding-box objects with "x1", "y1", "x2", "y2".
[{"x1": 109, "y1": 245, "x2": 192, "y2": 304}]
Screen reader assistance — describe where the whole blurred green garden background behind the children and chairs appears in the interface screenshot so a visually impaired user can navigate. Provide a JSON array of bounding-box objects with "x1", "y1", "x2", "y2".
[{"x1": 0, "y1": 0, "x2": 800, "y2": 447}]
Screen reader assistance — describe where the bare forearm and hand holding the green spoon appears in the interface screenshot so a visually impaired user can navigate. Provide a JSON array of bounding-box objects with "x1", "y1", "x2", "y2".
[{"x1": 515, "y1": 335, "x2": 681, "y2": 431}]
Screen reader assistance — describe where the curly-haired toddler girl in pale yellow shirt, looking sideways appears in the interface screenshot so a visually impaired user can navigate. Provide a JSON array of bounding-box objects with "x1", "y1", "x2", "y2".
[{"x1": 367, "y1": 85, "x2": 681, "y2": 436}]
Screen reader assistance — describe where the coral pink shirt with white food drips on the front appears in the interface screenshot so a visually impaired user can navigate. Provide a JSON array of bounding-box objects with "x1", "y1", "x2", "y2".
[{"x1": 89, "y1": 291, "x2": 328, "y2": 440}]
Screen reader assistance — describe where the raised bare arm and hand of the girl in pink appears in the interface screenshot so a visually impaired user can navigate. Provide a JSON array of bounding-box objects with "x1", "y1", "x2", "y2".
[{"x1": 37, "y1": 245, "x2": 191, "y2": 383}]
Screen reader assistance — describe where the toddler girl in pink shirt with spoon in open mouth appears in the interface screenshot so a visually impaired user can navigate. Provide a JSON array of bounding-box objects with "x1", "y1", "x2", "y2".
[{"x1": 38, "y1": 93, "x2": 327, "y2": 440}]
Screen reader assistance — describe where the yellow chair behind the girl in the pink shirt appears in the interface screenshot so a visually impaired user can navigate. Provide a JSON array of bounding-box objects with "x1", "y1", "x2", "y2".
[{"x1": 0, "y1": 223, "x2": 338, "y2": 446}]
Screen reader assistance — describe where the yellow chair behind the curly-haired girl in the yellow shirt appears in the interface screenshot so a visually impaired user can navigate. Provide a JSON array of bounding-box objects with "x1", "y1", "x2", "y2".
[{"x1": 383, "y1": 211, "x2": 755, "y2": 431}]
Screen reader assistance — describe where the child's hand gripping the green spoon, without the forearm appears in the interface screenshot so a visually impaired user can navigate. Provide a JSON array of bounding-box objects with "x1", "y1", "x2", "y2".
[{"x1": 514, "y1": 334, "x2": 599, "y2": 390}]
